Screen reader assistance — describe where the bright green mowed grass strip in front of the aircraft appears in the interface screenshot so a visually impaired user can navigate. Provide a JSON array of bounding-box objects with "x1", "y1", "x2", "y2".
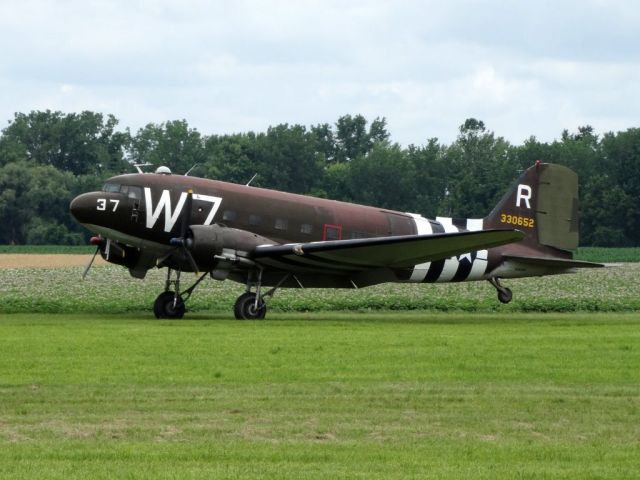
[{"x1": 0, "y1": 312, "x2": 640, "y2": 478}]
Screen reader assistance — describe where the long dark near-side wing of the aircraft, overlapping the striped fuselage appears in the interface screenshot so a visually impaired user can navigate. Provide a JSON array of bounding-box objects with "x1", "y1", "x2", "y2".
[{"x1": 252, "y1": 229, "x2": 525, "y2": 273}]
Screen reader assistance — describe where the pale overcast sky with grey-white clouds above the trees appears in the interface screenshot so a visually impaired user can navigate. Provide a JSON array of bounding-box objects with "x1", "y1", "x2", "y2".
[{"x1": 0, "y1": 0, "x2": 640, "y2": 145}]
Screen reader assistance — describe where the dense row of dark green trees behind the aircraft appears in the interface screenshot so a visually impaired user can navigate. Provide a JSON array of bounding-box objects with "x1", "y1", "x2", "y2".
[{"x1": 0, "y1": 111, "x2": 640, "y2": 246}]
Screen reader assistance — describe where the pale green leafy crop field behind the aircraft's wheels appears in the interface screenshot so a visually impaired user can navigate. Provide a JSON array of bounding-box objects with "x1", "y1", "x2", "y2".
[{"x1": 0, "y1": 255, "x2": 640, "y2": 315}]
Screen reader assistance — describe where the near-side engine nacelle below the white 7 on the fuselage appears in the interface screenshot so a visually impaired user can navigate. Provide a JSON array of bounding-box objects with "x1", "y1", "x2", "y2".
[{"x1": 186, "y1": 224, "x2": 274, "y2": 271}]
